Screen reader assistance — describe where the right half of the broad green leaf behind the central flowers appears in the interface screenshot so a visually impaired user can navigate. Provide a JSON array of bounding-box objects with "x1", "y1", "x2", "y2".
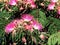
[{"x1": 38, "y1": 11, "x2": 49, "y2": 27}]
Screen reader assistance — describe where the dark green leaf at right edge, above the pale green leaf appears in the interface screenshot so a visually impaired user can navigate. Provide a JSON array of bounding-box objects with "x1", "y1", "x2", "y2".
[{"x1": 48, "y1": 17, "x2": 60, "y2": 34}]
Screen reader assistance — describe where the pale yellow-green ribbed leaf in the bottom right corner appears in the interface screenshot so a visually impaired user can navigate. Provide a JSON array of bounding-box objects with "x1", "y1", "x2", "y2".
[{"x1": 48, "y1": 32, "x2": 60, "y2": 45}]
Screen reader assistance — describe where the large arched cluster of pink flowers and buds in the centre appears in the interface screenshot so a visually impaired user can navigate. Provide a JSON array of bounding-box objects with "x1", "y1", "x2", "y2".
[{"x1": 5, "y1": 14, "x2": 43, "y2": 34}]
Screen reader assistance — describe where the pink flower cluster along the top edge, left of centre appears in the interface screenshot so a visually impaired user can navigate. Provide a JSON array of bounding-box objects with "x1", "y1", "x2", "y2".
[{"x1": 9, "y1": 0, "x2": 36, "y2": 8}]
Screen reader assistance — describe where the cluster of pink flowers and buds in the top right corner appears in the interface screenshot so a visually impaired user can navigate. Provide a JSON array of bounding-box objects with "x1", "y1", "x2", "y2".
[{"x1": 48, "y1": 0, "x2": 60, "y2": 18}]
